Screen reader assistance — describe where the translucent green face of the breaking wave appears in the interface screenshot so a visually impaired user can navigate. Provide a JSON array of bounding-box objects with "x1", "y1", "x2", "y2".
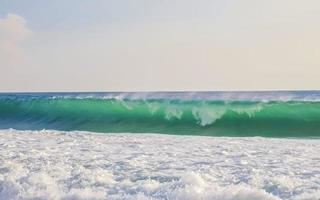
[{"x1": 0, "y1": 94, "x2": 320, "y2": 137}]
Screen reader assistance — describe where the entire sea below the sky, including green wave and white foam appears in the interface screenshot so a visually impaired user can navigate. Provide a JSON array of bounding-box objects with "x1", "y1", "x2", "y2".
[{"x1": 0, "y1": 91, "x2": 320, "y2": 200}]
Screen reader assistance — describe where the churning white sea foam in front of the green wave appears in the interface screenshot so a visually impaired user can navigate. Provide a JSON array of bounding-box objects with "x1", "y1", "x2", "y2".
[{"x1": 0, "y1": 130, "x2": 320, "y2": 200}]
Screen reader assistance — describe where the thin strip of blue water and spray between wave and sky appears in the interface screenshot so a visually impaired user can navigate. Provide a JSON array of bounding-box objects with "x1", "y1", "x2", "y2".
[{"x1": 0, "y1": 90, "x2": 320, "y2": 102}]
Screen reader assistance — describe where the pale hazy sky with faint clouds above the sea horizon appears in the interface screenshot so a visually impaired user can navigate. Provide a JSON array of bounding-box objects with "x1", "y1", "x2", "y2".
[{"x1": 0, "y1": 0, "x2": 320, "y2": 92}]
